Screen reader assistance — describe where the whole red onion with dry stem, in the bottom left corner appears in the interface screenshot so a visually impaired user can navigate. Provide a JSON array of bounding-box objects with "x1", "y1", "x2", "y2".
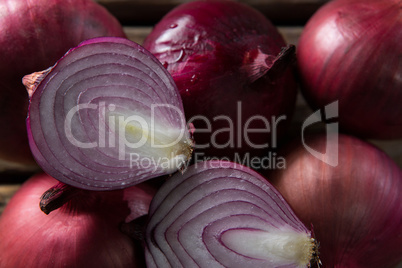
[{"x1": 0, "y1": 174, "x2": 154, "y2": 268}]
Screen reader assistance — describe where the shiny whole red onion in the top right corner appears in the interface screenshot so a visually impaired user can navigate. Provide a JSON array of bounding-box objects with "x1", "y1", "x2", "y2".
[{"x1": 297, "y1": 0, "x2": 402, "y2": 138}]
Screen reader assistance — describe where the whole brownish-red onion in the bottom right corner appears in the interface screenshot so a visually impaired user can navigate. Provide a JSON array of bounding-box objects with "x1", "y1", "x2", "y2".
[{"x1": 271, "y1": 135, "x2": 402, "y2": 268}]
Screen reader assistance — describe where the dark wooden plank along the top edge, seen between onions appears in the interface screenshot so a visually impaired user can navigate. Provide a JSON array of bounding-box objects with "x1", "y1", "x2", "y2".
[{"x1": 96, "y1": 0, "x2": 329, "y2": 25}]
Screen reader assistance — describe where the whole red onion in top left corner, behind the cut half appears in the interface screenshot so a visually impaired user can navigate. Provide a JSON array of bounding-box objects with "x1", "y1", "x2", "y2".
[{"x1": 0, "y1": 0, "x2": 125, "y2": 165}]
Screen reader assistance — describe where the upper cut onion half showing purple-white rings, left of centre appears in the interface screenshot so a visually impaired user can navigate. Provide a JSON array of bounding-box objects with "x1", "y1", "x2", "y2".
[{"x1": 24, "y1": 37, "x2": 192, "y2": 190}]
